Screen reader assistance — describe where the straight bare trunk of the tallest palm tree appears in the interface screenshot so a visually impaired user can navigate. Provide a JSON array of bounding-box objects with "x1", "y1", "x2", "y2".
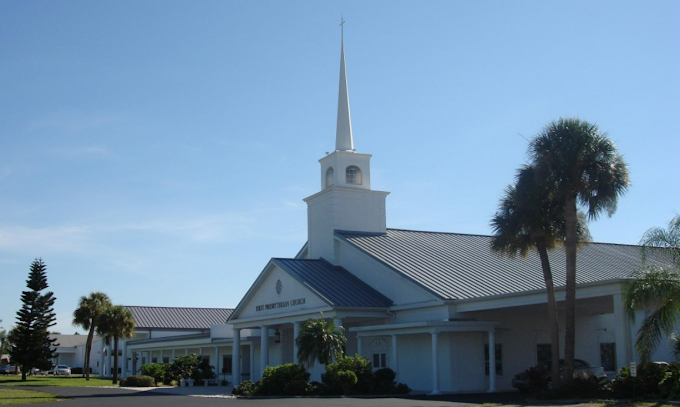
[{"x1": 564, "y1": 194, "x2": 578, "y2": 382}]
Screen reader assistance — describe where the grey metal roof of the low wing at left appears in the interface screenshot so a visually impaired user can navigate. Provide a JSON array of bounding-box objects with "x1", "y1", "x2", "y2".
[{"x1": 125, "y1": 306, "x2": 234, "y2": 329}]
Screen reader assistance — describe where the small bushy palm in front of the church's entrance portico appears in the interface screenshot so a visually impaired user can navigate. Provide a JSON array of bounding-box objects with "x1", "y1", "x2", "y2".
[{"x1": 295, "y1": 316, "x2": 347, "y2": 366}]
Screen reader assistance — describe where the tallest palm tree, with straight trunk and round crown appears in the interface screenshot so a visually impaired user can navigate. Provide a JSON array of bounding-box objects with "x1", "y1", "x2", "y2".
[{"x1": 529, "y1": 118, "x2": 629, "y2": 380}]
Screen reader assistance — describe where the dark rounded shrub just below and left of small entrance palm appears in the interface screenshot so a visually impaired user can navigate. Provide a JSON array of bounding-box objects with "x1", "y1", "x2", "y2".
[{"x1": 256, "y1": 363, "x2": 309, "y2": 396}]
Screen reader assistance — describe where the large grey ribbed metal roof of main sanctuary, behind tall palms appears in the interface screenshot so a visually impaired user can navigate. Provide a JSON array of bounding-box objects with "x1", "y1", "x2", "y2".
[{"x1": 336, "y1": 229, "x2": 658, "y2": 299}]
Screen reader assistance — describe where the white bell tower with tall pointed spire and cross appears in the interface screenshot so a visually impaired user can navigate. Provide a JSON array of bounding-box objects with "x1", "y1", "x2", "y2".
[{"x1": 304, "y1": 21, "x2": 389, "y2": 265}]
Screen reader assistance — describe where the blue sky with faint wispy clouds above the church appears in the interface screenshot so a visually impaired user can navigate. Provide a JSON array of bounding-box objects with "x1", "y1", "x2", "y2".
[{"x1": 0, "y1": 0, "x2": 680, "y2": 333}]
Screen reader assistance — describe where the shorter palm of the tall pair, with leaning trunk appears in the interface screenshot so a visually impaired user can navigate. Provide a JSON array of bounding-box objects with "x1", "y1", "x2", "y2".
[{"x1": 491, "y1": 165, "x2": 589, "y2": 385}]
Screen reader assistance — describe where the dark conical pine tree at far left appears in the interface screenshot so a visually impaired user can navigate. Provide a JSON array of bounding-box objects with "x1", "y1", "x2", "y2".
[{"x1": 10, "y1": 259, "x2": 58, "y2": 381}]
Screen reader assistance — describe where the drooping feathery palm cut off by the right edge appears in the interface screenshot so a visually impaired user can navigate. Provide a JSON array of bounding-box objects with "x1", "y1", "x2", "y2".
[{"x1": 623, "y1": 216, "x2": 680, "y2": 362}]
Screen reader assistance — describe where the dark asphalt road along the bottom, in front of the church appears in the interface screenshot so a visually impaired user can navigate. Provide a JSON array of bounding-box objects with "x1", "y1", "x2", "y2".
[{"x1": 9, "y1": 387, "x2": 596, "y2": 407}]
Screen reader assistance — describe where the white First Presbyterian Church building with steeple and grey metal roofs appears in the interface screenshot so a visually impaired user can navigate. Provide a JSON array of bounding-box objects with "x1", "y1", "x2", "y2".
[{"x1": 94, "y1": 32, "x2": 671, "y2": 394}]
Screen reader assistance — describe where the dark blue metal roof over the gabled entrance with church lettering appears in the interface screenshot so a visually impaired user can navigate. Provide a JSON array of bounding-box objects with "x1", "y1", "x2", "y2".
[{"x1": 272, "y1": 258, "x2": 392, "y2": 308}]
